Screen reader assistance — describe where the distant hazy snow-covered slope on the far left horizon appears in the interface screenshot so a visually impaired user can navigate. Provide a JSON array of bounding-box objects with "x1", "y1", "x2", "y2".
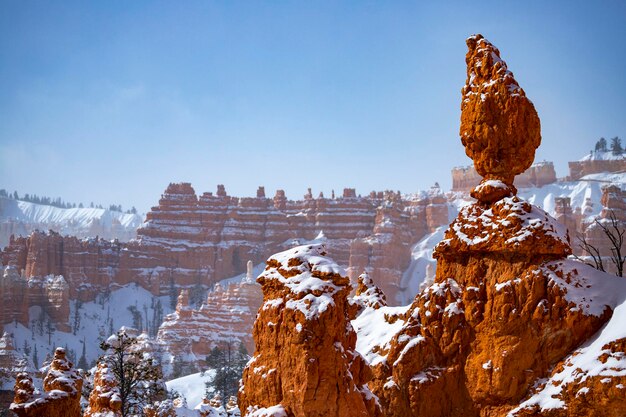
[{"x1": 0, "y1": 197, "x2": 143, "y2": 247}]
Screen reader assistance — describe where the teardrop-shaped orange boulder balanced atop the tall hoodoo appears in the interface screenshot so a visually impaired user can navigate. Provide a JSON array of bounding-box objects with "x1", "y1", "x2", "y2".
[{"x1": 460, "y1": 35, "x2": 541, "y2": 185}]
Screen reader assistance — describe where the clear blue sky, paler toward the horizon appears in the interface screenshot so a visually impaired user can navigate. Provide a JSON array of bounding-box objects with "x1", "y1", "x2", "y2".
[{"x1": 0, "y1": 0, "x2": 626, "y2": 212}]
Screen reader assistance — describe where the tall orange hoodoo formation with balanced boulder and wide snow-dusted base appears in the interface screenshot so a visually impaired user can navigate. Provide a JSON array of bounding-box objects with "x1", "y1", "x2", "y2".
[{"x1": 370, "y1": 35, "x2": 615, "y2": 417}]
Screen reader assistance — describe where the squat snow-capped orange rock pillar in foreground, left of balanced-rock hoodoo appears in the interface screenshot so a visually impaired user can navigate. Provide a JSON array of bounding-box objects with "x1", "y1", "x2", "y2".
[{"x1": 239, "y1": 244, "x2": 376, "y2": 417}]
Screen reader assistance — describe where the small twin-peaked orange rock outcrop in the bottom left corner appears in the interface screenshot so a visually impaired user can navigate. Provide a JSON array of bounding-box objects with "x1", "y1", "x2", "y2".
[{"x1": 10, "y1": 348, "x2": 83, "y2": 417}]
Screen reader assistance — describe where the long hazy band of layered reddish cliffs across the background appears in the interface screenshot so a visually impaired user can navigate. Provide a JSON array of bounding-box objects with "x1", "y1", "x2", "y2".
[{"x1": 0, "y1": 183, "x2": 448, "y2": 330}]
